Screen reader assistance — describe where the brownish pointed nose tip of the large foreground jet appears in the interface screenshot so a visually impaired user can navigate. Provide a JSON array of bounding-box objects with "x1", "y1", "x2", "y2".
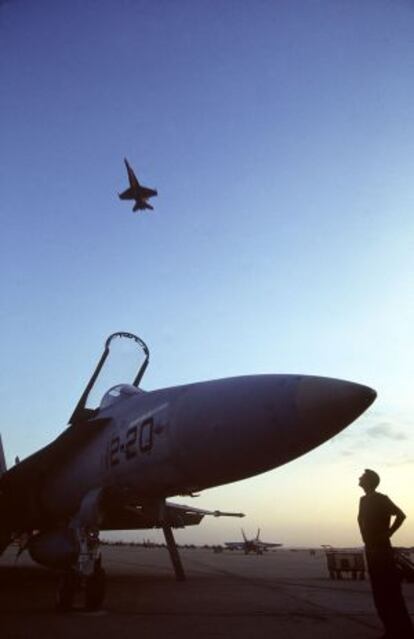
[{"x1": 296, "y1": 377, "x2": 377, "y2": 441}]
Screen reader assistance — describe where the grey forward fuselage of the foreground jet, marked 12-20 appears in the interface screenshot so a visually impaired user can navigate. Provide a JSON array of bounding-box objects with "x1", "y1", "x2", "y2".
[{"x1": 35, "y1": 375, "x2": 373, "y2": 519}]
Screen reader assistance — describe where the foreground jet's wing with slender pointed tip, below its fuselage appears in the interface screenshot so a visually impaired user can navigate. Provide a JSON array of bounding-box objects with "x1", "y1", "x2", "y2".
[{"x1": 101, "y1": 500, "x2": 244, "y2": 530}]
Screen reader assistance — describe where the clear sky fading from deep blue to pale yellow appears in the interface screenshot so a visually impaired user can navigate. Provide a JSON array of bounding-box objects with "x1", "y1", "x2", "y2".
[{"x1": 0, "y1": 0, "x2": 414, "y2": 545}]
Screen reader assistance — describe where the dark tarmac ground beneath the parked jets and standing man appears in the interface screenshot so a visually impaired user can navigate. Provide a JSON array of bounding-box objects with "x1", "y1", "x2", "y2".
[{"x1": 0, "y1": 546, "x2": 414, "y2": 639}]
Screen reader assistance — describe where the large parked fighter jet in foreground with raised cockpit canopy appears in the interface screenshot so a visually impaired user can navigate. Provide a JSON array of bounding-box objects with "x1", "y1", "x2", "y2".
[{"x1": 0, "y1": 333, "x2": 376, "y2": 609}]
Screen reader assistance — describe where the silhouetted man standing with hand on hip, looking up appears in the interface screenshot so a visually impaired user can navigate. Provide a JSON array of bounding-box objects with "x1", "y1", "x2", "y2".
[{"x1": 358, "y1": 469, "x2": 414, "y2": 639}]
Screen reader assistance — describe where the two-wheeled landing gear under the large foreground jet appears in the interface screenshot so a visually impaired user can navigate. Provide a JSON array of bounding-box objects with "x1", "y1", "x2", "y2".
[{"x1": 56, "y1": 532, "x2": 106, "y2": 612}]
